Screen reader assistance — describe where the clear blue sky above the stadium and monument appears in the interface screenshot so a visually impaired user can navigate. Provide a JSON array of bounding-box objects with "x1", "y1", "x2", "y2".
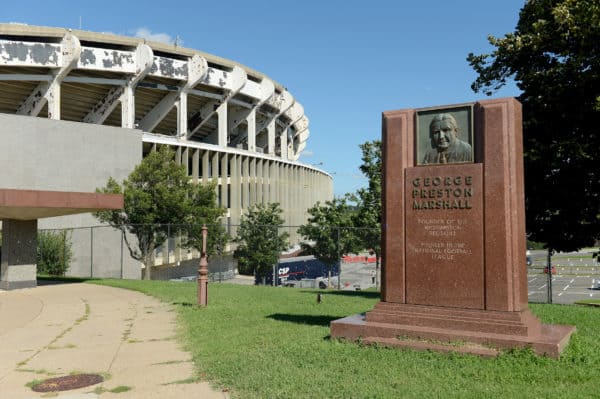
[{"x1": 0, "y1": 0, "x2": 524, "y2": 195}]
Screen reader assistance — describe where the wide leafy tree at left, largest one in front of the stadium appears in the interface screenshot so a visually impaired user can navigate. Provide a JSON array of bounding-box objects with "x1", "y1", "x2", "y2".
[{"x1": 95, "y1": 146, "x2": 224, "y2": 279}]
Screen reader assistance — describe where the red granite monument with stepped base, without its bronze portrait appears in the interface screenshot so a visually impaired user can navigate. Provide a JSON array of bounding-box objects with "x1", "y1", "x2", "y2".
[{"x1": 331, "y1": 98, "x2": 575, "y2": 357}]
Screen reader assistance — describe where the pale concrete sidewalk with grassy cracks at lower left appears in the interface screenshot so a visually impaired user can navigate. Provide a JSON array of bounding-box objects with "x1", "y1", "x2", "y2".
[{"x1": 0, "y1": 283, "x2": 228, "y2": 399}]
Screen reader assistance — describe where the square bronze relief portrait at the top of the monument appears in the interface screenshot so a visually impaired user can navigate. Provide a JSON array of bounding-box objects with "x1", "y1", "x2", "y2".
[{"x1": 415, "y1": 105, "x2": 473, "y2": 165}]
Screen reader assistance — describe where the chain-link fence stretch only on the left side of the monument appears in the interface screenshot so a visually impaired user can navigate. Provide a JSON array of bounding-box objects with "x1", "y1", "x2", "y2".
[{"x1": 38, "y1": 224, "x2": 380, "y2": 290}]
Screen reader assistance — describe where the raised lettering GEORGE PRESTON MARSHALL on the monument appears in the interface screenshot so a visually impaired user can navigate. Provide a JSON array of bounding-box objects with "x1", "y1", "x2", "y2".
[{"x1": 412, "y1": 176, "x2": 473, "y2": 210}]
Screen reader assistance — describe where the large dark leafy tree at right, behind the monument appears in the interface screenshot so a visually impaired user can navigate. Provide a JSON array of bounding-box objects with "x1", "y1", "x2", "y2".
[{"x1": 467, "y1": 0, "x2": 600, "y2": 251}]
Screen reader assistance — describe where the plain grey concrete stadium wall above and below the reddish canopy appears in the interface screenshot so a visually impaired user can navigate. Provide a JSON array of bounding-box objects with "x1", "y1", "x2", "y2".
[{"x1": 0, "y1": 114, "x2": 142, "y2": 278}]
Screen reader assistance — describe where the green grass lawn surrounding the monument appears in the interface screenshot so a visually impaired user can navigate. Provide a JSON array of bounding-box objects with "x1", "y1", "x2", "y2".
[{"x1": 89, "y1": 280, "x2": 600, "y2": 398}]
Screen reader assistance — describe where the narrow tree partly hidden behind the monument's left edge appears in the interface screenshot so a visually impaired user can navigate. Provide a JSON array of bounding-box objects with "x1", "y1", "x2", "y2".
[{"x1": 352, "y1": 140, "x2": 383, "y2": 284}]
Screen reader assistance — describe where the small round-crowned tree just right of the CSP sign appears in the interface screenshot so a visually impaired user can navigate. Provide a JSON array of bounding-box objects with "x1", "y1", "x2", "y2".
[{"x1": 298, "y1": 198, "x2": 357, "y2": 285}]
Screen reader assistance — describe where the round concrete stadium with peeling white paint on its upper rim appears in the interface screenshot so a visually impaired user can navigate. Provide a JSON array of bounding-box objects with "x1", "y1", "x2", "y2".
[{"x1": 0, "y1": 24, "x2": 333, "y2": 284}]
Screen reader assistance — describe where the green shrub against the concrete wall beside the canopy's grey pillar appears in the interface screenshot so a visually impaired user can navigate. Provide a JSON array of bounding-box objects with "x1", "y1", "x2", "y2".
[{"x1": 36, "y1": 230, "x2": 73, "y2": 276}]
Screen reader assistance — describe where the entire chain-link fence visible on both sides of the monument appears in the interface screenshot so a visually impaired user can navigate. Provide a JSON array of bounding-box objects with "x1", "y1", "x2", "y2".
[{"x1": 32, "y1": 224, "x2": 600, "y2": 303}]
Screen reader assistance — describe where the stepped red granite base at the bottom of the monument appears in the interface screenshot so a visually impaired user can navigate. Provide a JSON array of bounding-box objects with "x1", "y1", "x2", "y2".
[{"x1": 331, "y1": 302, "x2": 575, "y2": 358}]
